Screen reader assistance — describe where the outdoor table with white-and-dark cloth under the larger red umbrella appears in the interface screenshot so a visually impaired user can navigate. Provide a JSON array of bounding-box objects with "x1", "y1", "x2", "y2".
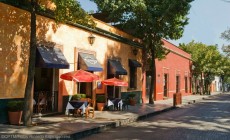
[{"x1": 66, "y1": 101, "x2": 88, "y2": 114}]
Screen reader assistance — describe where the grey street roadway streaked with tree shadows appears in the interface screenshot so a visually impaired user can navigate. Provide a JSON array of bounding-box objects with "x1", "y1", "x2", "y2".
[{"x1": 83, "y1": 93, "x2": 230, "y2": 140}]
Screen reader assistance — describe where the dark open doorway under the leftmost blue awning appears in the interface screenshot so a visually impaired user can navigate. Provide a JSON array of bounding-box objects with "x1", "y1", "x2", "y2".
[{"x1": 34, "y1": 68, "x2": 59, "y2": 114}]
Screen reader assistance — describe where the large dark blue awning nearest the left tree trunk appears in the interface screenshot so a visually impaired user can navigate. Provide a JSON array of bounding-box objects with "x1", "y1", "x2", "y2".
[{"x1": 36, "y1": 45, "x2": 69, "y2": 69}]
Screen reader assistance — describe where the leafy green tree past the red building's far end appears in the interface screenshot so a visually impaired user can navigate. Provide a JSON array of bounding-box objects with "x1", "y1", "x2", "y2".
[{"x1": 179, "y1": 41, "x2": 223, "y2": 94}]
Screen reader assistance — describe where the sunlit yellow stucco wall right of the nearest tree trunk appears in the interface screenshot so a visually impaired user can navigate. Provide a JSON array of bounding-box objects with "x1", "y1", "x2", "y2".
[{"x1": 37, "y1": 16, "x2": 141, "y2": 95}]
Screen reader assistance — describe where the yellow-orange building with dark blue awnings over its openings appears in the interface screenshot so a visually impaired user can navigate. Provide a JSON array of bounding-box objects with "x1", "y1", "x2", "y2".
[{"x1": 0, "y1": 2, "x2": 142, "y2": 122}]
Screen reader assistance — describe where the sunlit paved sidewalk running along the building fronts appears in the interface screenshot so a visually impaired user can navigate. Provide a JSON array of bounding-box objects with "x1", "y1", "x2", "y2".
[{"x1": 0, "y1": 92, "x2": 223, "y2": 139}]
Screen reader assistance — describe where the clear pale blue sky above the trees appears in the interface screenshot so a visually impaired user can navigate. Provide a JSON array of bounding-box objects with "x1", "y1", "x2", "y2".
[{"x1": 78, "y1": 0, "x2": 230, "y2": 48}]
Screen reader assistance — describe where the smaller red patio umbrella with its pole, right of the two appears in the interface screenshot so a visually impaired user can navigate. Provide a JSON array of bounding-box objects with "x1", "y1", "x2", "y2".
[{"x1": 101, "y1": 77, "x2": 128, "y2": 97}]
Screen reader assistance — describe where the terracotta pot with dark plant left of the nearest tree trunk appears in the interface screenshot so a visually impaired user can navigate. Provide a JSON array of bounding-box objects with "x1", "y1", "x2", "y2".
[{"x1": 7, "y1": 100, "x2": 24, "y2": 125}]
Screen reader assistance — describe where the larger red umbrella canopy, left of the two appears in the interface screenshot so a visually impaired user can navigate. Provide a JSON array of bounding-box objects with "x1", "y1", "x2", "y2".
[{"x1": 61, "y1": 70, "x2": 99, "y2": 82}]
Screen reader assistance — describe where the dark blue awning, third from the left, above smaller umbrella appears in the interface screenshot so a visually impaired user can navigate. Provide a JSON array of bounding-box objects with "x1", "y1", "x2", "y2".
[{"x1": 108, "y1": 60, "x2": 127, "y2": 75}]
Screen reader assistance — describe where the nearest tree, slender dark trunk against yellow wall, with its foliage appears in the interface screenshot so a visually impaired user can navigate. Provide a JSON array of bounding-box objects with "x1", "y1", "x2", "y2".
[{"x1": 23, "y1": 0, "x2": 92, "y2": 126}]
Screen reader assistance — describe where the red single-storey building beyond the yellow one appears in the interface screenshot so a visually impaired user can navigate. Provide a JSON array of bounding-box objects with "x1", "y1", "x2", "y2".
[{"x1": 142, "y1": 40, "x2": 192, "y2": 102}]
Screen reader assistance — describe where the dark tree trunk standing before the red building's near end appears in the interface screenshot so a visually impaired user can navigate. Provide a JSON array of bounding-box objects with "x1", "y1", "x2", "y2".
[{"x1": 149, "y1": 49, "x2": 156, "y2": 104}]
